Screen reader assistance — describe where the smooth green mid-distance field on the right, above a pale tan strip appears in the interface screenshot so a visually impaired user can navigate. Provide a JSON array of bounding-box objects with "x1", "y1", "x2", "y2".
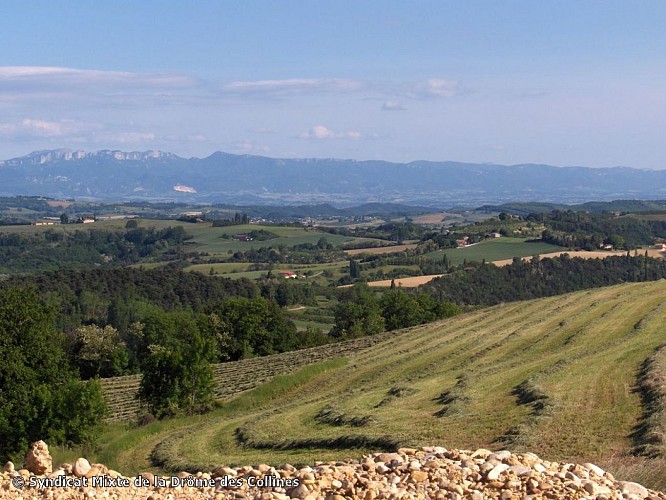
[{"x1": 424, "y1": 238, "x2": 566, "y2": 265}]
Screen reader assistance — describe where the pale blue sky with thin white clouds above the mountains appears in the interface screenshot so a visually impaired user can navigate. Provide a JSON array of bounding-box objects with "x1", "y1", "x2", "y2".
[{"x1": 0, "y1": 0, "x2": 666, "y2": 169}]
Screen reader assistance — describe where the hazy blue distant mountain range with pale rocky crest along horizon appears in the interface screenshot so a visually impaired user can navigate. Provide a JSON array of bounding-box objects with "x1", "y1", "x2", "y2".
[{"x1": 0, "y1": 149, "x2": 666, "y2": 208}]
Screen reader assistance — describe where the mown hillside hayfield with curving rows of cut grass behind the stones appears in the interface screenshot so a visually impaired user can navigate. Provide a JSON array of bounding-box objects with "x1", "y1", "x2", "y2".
[{"x1": 80, "y1": 280, "x2": 666, "y2": 488}]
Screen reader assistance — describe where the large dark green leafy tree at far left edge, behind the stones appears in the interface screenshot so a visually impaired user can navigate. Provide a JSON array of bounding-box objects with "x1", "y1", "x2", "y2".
[{"x1": 0, "y1": 288, "x2": 104, "y2": 457}]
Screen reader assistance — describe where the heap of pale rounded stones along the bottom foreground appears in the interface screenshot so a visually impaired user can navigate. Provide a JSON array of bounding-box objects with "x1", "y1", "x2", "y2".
[{"x1": 0, "y1": 441, "x2": 666, "y2": 500}]
